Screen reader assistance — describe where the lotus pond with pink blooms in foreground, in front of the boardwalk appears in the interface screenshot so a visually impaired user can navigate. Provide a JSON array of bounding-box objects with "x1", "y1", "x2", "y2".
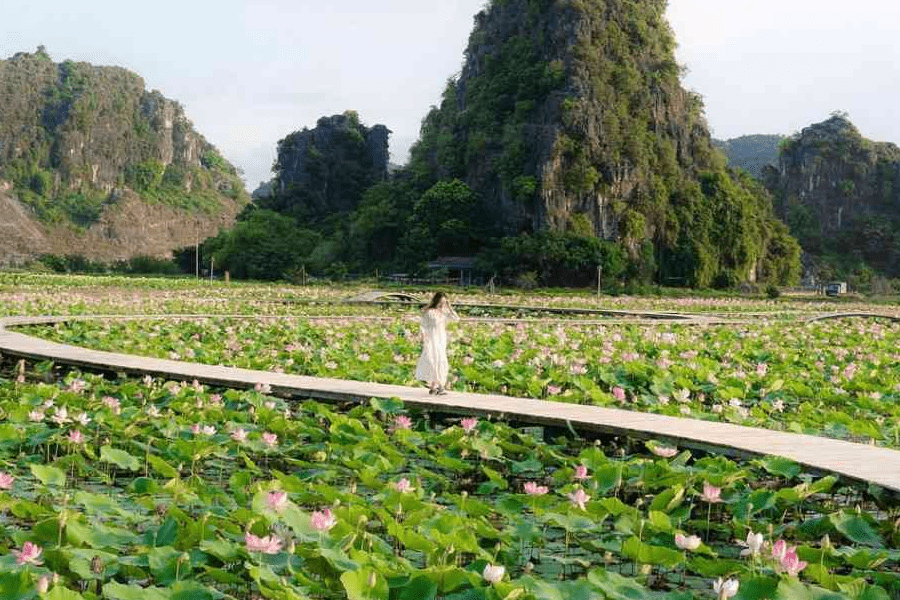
[{"x1": 0, "y1": 363, "x2": 900, "y2": 600}]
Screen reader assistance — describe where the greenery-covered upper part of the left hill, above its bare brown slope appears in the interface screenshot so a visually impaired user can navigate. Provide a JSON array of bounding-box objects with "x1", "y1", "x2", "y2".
[{"x1": 0, "y1": 48, "x2": 248, "y2": 258}]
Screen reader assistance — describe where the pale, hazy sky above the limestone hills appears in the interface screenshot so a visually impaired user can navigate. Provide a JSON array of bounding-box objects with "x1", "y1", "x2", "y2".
[{"x1": 0, "y1": 0, "x2": 900, "y2": 191}]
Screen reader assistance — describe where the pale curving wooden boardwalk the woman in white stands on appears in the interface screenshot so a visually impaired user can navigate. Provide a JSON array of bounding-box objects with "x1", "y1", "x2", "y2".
[{"x1": 0, "y1": 316, "x2": 900, "y2": 493}]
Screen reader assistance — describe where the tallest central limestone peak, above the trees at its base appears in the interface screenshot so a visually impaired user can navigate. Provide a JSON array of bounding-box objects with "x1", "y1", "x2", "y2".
[{"x1": 411, "y1": 0, "x2": 796, "y2": 285}]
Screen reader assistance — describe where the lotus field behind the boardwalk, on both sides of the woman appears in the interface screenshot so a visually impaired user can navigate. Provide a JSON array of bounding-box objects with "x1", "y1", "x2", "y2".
[{"x1": 28, "y1": 309, "x2": 900, "y2": 447}]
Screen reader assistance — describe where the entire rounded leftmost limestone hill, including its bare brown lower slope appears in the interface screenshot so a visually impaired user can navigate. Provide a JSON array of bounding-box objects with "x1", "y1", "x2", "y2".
[{"x1": 0, "y1": 49, "x2": 247, "y2": 262}]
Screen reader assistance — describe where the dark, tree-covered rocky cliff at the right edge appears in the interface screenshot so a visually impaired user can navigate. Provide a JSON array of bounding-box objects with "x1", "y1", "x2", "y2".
[{"x1": 764, "y1": 114, "x2": 900, "y2": 276}]
